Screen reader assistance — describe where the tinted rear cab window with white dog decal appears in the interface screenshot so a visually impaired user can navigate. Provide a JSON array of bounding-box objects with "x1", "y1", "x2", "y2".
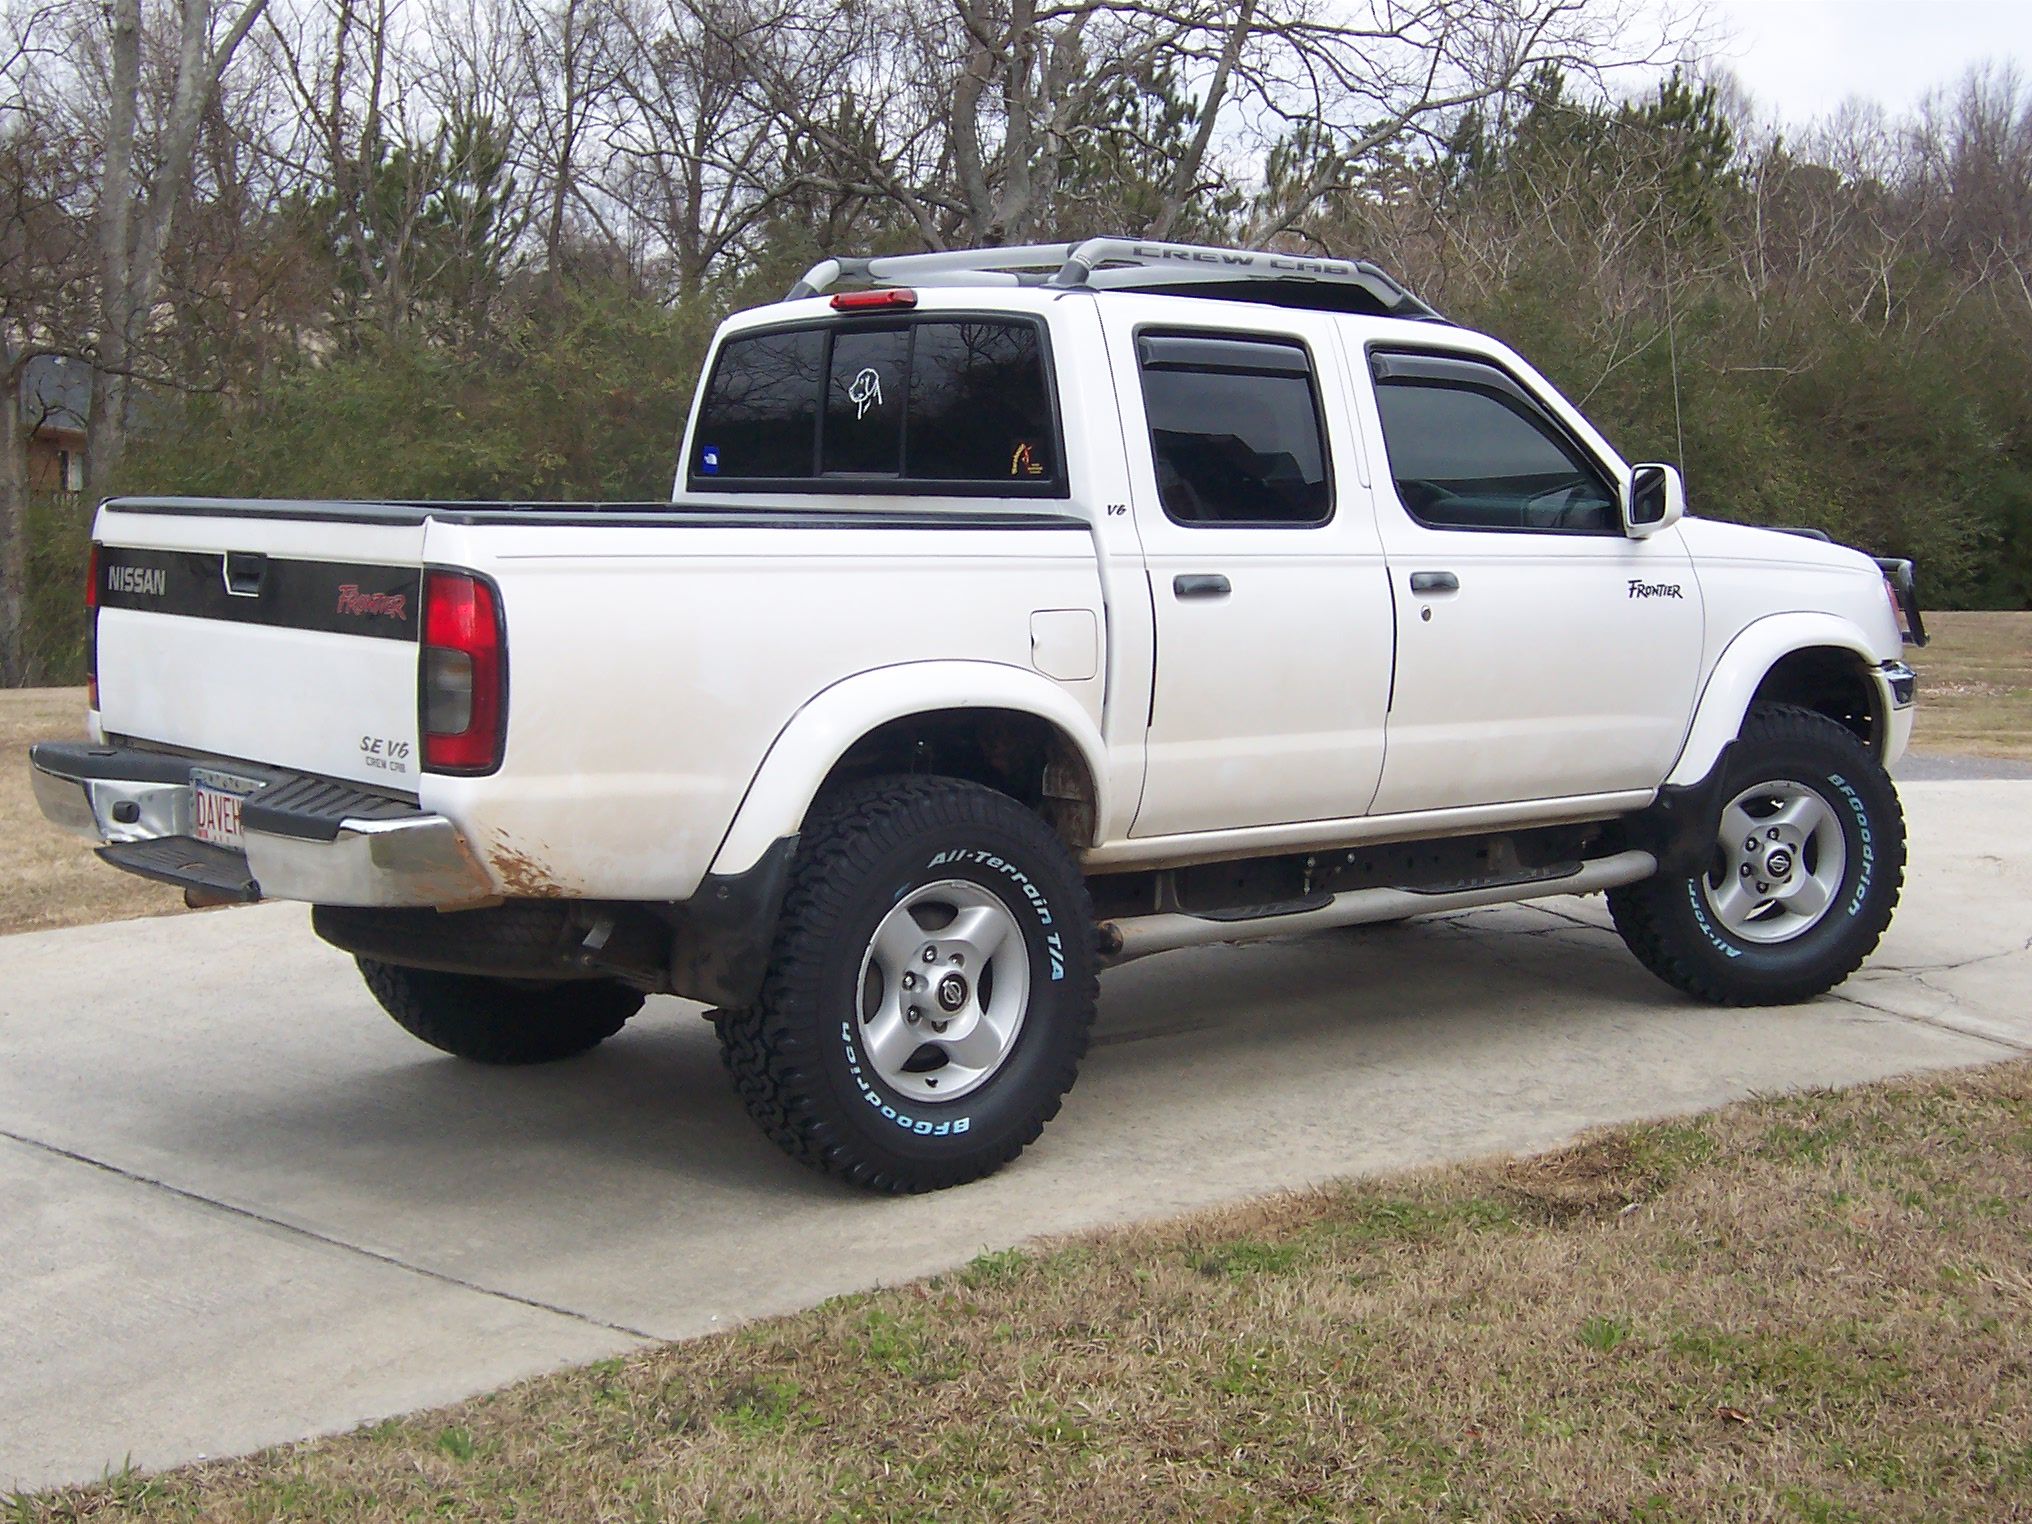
[{"x1": 689, "y1": 317, "x2": 1065, "y2": 496}]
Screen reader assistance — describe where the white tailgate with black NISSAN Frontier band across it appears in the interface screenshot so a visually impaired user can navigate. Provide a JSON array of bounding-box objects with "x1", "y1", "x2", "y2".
[{"x1": 93, "y1": 502, "x2": 425, "y2": 792}]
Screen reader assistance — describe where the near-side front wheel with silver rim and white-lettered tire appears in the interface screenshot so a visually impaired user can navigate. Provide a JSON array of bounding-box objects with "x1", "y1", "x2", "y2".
[{"x1": 1609, "y1": 705, "x2": 1906, "y2": 1006}]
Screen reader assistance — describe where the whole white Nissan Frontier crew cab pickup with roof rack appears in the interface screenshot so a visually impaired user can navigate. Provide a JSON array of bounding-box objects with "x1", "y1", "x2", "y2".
[{"x1": 33, "y1": 240, "x2": 1924, "y2": 1191}]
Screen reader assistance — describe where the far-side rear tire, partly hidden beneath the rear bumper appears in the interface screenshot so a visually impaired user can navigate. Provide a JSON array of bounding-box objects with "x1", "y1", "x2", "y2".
[{"x1": 354, "y1": 957, "x2": 642, "y2": 1065}]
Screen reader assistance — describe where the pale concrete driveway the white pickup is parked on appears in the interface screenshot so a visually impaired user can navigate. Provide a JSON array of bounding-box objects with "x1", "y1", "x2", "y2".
[{"x1": 0, "y1": 780, "x2": 2032, "y2": 1491}]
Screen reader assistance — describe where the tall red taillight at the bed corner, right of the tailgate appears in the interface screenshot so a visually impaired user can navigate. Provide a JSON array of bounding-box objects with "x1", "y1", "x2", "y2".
[{"x1": 419, "y1": 571, "x2": 508, "y2": 772}]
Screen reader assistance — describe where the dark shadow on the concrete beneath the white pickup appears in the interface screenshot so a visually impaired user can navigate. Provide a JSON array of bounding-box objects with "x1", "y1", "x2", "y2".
[{"x1": 170, "y1": 912, "x2": 1685, "y2": 1211}]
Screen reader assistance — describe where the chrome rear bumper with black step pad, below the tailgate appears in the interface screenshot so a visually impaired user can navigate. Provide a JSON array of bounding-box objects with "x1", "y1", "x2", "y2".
[{"x1": 28, "y1": 742, "x2": 500, "y2": 910}]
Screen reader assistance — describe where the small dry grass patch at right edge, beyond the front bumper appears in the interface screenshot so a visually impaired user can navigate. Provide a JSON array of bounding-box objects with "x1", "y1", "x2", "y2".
[{"x1": 1906, "y1": 614, "x2": 2032, "y2": 762}]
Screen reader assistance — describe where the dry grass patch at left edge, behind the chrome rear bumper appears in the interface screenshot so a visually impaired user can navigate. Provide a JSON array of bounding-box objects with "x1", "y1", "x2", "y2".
[{"x1": 0, "y1": 689, "x2": 183, "y2": 935}]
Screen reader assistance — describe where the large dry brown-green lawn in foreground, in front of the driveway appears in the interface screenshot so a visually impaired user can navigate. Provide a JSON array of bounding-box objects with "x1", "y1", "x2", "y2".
[{"x1": 14, "y1": 1063, "x2": 2032, "y2": 1524}]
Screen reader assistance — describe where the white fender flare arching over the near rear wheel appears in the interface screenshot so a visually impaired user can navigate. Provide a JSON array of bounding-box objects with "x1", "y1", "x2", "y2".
[{"x1": 709, "y1": 660, "x2": 1107, "y2": 874}]
